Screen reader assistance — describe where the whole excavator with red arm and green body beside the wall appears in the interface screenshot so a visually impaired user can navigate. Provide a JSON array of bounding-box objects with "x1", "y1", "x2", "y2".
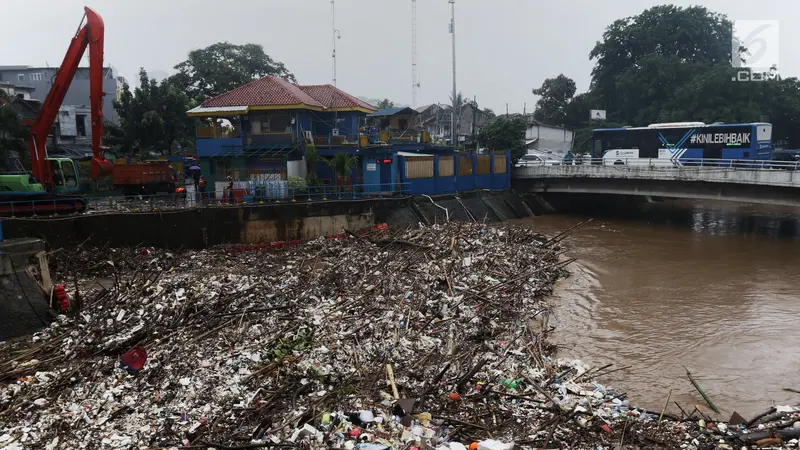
[{"x1": 0, "y1": 7, "x2": 114, "y2": 216}]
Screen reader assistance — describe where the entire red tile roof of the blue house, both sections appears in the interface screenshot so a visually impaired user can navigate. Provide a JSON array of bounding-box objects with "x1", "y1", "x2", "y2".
[{"x1": 201, "y1": 76, "x2": 376, "y2": 111}]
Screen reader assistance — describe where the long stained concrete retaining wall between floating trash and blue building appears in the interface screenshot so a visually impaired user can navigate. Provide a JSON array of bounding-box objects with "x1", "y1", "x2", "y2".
[{"x1": 3, "y1": 192, "x2": 531, "y2": 249}]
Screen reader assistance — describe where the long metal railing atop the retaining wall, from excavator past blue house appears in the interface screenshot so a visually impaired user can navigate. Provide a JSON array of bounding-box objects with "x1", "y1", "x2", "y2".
[{"x1": 0, "y1": 183, "x2": 411, "y2": 217}]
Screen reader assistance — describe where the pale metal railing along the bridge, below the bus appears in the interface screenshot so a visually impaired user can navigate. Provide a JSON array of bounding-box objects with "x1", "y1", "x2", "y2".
[{"x1": 515, "y1": 158, "x2": 800, "y2": 170}]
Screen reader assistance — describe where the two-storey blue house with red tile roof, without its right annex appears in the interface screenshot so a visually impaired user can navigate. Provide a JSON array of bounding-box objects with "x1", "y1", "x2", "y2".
[{"x1": 187, "y1": 77, "x2": 376, "y2": 188}]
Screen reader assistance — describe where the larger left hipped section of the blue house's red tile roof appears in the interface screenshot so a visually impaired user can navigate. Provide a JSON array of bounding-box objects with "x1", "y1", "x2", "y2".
[{"x1": 201, "y1": 77, "x2": 325, "y2": 108}]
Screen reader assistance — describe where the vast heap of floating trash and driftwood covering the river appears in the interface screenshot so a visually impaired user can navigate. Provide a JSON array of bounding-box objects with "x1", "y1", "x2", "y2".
[{"x1": 0, "y1": 224, "x2": 800, "y2": 450}]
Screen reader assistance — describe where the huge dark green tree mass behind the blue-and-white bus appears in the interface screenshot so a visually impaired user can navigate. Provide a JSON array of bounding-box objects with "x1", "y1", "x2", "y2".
[{"x1": 552, "y1": 5, "x2": 800, "y2": 150}]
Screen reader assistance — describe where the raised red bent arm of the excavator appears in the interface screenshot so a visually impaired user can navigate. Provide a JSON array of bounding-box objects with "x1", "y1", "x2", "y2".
[{"x1": 28, "y1": 8, "x2": 113, "y2": 191}]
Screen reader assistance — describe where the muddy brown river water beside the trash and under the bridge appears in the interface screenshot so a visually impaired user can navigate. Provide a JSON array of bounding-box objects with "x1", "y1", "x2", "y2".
[{"x1": 524, "y1": 203, "x2": 800, "y2": 418}]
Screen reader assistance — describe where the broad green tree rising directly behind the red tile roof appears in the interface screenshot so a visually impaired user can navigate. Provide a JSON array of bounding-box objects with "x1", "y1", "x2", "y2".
[{"x1": 169, "y1": 42, "x2": 297, "y2": 100}]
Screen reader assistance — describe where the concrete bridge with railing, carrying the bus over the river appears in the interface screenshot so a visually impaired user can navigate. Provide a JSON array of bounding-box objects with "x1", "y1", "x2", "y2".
[{"x1": 512, "y1": 159, "x2": 800, "y2": 207}]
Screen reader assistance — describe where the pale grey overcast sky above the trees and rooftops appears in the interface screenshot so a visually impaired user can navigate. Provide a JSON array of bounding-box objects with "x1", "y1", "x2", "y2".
[{"x1": 0, "y1": 0, "x2": 800, "y2": 113}]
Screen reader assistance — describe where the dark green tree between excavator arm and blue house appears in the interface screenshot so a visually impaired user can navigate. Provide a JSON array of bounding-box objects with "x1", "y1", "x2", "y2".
[{"x1": 113, "y1": 69, "x2": 194, "y2": 155}]
